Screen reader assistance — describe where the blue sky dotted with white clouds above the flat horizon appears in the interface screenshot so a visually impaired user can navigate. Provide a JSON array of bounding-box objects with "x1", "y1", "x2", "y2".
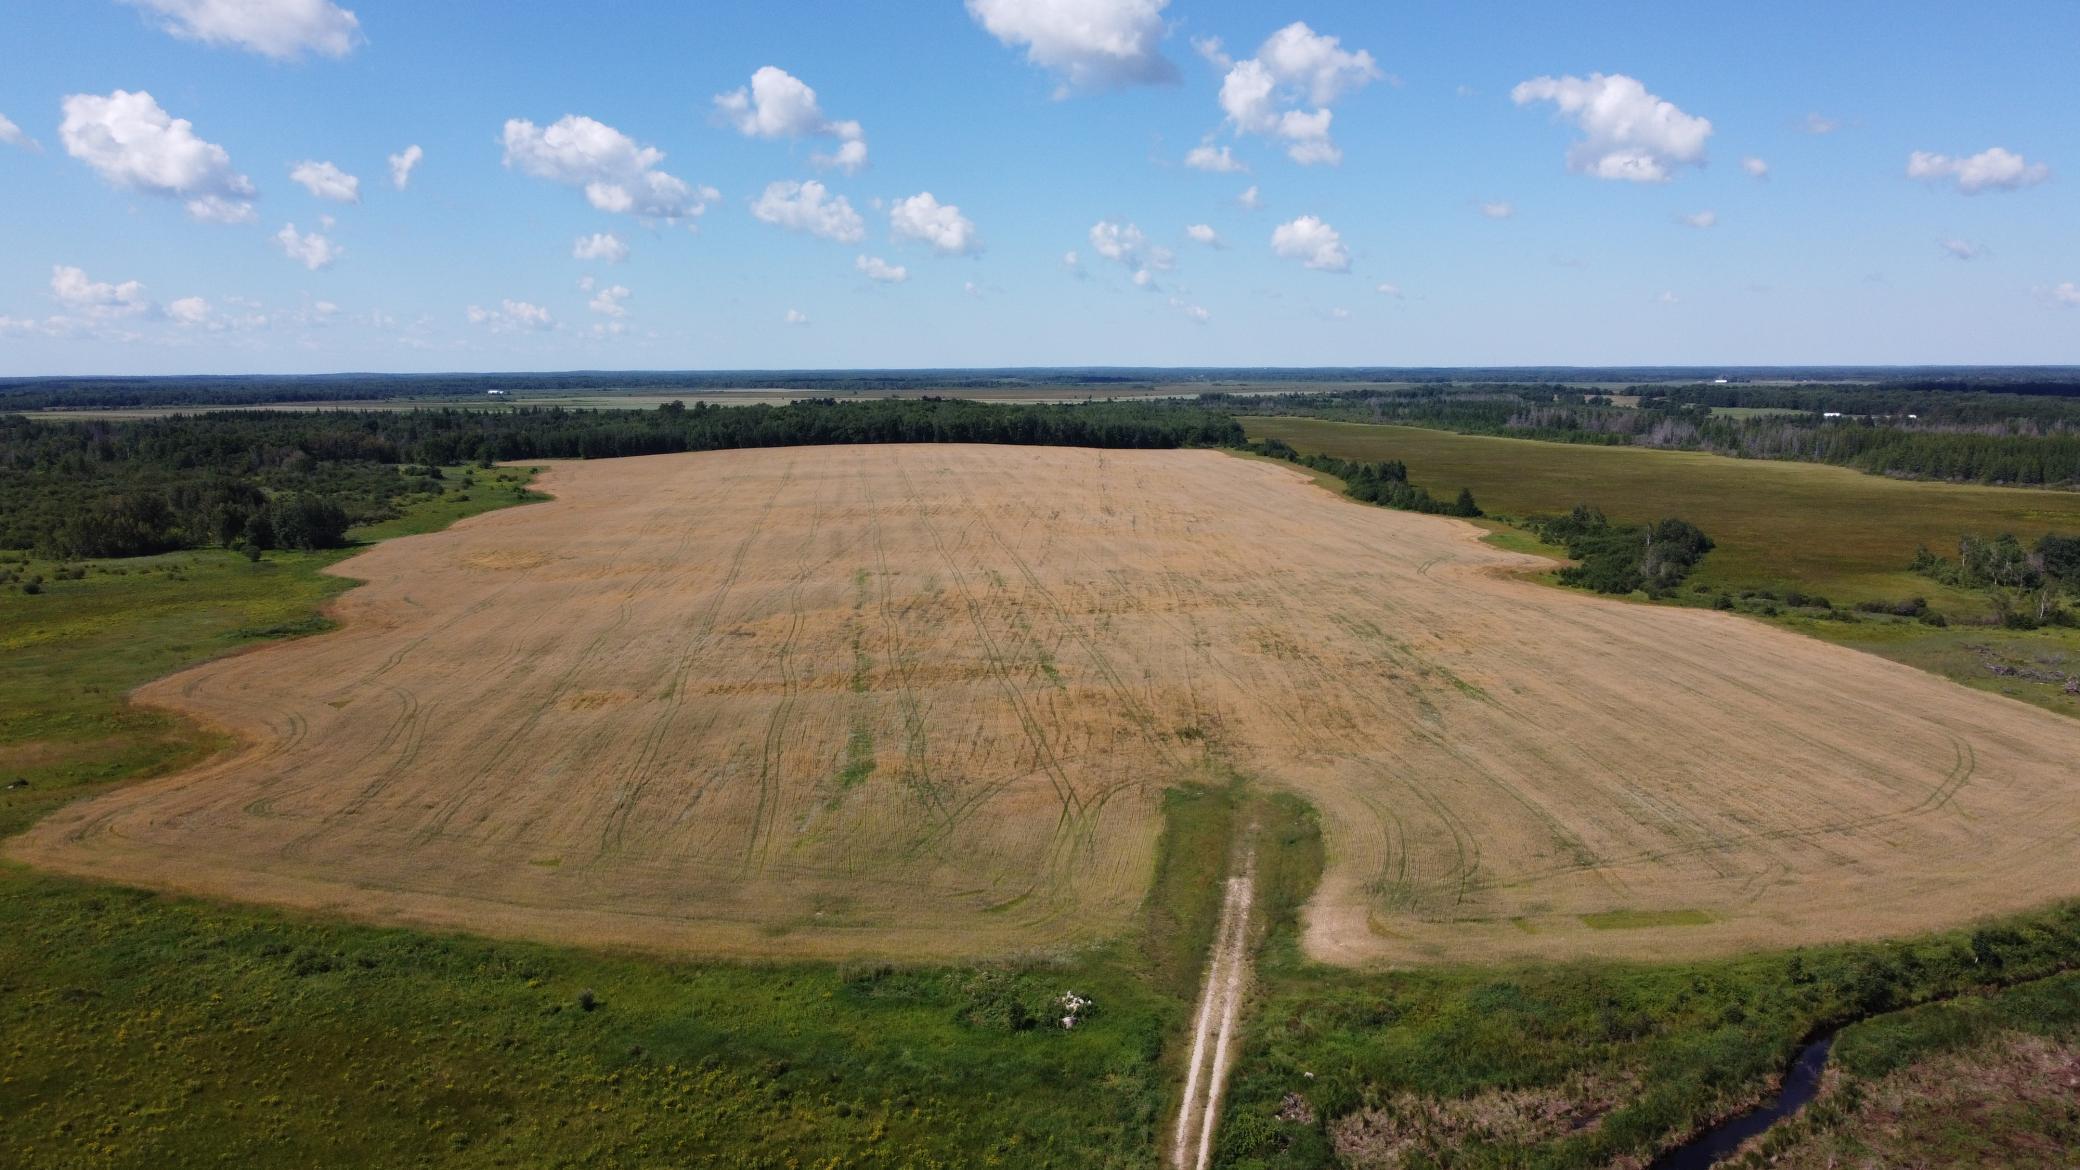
[{"x1": 0, "y1": 0, "x2": 2080, "y2": 375}]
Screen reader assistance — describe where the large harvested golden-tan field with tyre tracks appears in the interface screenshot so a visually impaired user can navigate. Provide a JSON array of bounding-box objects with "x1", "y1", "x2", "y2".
[{"x1": 10, "y1": 446, "x2": 2080, "y2": 964}]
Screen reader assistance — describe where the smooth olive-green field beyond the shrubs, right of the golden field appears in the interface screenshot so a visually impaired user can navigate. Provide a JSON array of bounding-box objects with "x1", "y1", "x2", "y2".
[{"x1": 1242, "y1": 418, "x2": 2080, "y2": 599}]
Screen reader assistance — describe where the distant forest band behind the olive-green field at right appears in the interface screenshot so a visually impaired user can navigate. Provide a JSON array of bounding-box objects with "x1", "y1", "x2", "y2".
[{"x1": 1200, "y1": 383, "x2": 2080, "y2": 485}]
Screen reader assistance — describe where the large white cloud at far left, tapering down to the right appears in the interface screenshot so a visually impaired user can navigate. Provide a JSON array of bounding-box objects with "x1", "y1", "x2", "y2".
[{"x1": 58, "y1": 90, "x2": 256, "y2": 223}]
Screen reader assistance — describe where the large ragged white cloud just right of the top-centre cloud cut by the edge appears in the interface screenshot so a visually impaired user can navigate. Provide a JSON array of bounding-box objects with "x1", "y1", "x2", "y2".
[{"x1": 1221, "y1": 21, "x2": 1383, "y2": 167}]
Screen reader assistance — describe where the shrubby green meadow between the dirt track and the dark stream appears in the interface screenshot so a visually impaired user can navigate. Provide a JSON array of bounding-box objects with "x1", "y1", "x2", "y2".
[{"x1": 1221, "y1": 906, "x2": 2080, "y2": 1170}]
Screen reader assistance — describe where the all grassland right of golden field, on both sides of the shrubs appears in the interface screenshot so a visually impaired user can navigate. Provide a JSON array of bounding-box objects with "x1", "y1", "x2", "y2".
[{"x1": 1244, "y1": 410, "x2": 2080, "y2": 716}]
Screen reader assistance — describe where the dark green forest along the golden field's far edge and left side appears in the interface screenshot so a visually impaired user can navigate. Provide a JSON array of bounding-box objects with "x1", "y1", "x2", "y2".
[{"x1": 0, "y1": 398, "x2": 1244, "y2": 558}]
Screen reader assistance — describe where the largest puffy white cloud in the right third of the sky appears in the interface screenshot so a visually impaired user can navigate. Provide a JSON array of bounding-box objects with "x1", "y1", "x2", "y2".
[{"x1": 1510, "y1": 73, "x2": 1712, "y2": 183}]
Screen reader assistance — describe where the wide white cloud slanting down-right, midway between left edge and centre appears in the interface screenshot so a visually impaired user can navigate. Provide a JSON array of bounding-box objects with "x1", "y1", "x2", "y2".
[{"x1": 503, "y1": 115, "x2": 722, "y2": 221}]
